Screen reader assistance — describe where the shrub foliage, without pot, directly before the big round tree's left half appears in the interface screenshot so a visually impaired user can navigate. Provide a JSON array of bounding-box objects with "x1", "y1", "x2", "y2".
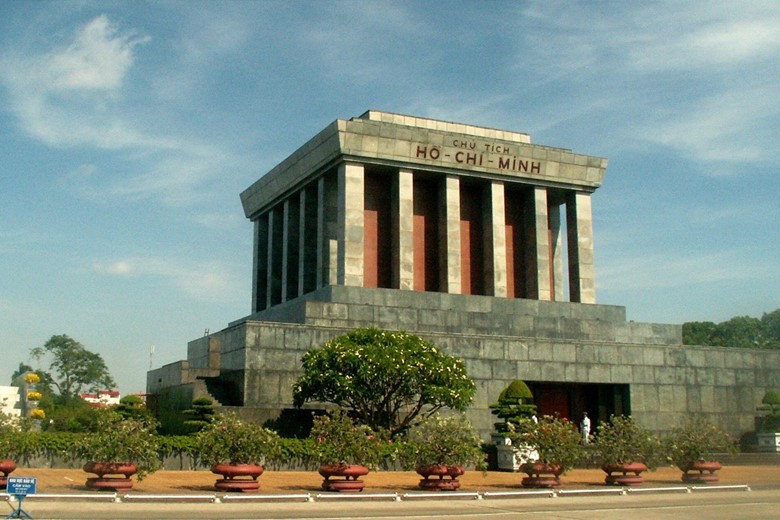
[{"x1": 311, "y1": 410, "x2": 390, "y2": 469}]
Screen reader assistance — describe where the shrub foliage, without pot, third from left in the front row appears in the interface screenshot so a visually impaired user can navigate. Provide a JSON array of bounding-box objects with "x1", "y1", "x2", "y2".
[{"x1": 195, "y1": 413, "x2": 280, "y2": 466}]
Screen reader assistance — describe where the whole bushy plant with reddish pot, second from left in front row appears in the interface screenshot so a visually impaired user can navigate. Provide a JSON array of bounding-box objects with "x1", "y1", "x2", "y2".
[{"x1": 73, "y1": 410, "x2": 160, "y2": 491}]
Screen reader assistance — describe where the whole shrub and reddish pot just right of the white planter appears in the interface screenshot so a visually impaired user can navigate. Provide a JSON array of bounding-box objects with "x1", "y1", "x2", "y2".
[{"x1": 509, "y1": 415, "x2": 584, "y2": 488}]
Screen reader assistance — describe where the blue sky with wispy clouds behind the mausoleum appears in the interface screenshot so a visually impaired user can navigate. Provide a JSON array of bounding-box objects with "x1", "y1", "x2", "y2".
[{"x1": 0, "y1": 0, "x2": 780, "y2": 393}]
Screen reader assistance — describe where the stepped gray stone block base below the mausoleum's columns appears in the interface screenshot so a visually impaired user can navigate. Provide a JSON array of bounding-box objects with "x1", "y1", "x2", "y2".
[{"x1": 148, "y1": 286, "x2": 780, "y2": 438}]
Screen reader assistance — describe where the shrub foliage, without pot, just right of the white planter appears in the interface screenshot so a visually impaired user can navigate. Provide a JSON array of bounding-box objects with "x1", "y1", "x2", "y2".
[{"x1": 509, "y1": 415, "x2": 585, "y2": 471}]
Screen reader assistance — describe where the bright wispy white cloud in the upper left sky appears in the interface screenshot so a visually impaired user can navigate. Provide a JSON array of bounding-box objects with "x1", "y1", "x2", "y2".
[{"x1": 0, "y1": 15, "x2": 241, "y2": 205}]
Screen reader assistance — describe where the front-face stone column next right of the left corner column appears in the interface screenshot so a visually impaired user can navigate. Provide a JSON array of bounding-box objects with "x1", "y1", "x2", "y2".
[{"x1": 393, "y1": 169, "x2": 414, "y2": 291}]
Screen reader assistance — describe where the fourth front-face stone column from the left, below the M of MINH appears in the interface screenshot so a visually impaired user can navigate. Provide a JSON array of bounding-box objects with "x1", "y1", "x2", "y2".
[{"x1": 485, "y1": 181, "x2": 507, "y2": 298}]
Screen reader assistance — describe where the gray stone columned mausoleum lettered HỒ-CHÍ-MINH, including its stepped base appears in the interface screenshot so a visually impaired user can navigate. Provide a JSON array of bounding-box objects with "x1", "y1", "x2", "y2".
[{"x1": 147, "y1": 110, "x2": 780, "y2": 436}]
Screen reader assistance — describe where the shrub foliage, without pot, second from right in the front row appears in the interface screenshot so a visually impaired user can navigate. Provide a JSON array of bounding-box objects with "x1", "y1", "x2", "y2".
[{"x1": 588, "y1": 415, "x2": 661, "y2": 469}]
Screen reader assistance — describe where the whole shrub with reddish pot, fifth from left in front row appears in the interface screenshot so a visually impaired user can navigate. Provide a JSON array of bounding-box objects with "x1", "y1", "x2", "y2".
[{"x1": 401, "y1": 413, "x2": 486, "y2": 491}]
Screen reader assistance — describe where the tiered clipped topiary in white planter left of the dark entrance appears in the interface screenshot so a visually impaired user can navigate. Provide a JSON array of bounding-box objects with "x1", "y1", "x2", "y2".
[{"x1": 490, "y1": 379, "x2": 539, "y2": 471}]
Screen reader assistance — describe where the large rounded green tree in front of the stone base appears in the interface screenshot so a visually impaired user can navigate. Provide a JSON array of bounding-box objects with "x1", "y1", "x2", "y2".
[{"x1": 293, "y1": 328, "x2": 475, "y2": 436}]
